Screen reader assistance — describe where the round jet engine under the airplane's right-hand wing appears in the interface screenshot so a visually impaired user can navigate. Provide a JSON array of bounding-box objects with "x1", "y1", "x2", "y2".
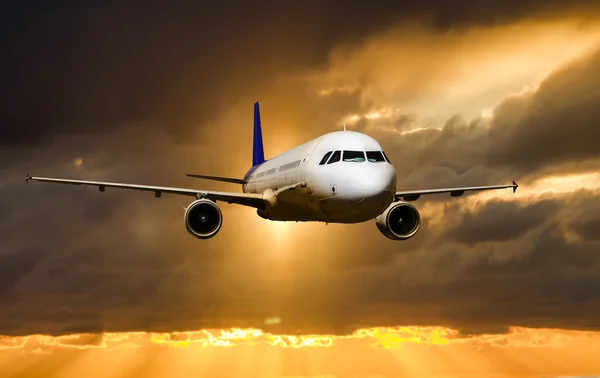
[{"x1": 375, "y1": 202, "x2": 421, "y2": 240}]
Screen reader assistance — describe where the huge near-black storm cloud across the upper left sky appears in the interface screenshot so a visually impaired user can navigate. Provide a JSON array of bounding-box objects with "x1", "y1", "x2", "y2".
[{"x1": 0, "y1": 0, "x2": 599, "y2": 146}]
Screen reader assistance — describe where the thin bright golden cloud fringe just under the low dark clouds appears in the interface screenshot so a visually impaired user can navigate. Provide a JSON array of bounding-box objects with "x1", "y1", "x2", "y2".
[{"x1": 0, "y1": 326, "x2": 600, "y2": 352}]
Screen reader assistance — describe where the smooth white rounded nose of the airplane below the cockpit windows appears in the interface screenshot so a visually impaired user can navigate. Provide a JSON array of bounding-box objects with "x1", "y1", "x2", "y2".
[{"x1": 346, "y1": 163, "x2": 396, "y2": 201}]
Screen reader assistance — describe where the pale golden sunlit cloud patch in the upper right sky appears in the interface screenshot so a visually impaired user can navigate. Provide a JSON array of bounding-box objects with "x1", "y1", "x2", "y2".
[{"x1": 309, "y1": 21, "x2": 600, "y2": 122}]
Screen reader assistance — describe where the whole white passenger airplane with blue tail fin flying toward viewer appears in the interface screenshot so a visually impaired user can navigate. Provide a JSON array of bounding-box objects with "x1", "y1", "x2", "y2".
[{"x1": 25, "y1": 102, "x2": 518, "y2": 240}]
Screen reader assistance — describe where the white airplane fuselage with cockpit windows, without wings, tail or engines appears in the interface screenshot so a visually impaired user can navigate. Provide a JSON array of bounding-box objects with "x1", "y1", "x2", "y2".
[{"x1": 243, "y1": 131, "x2": 396, "y2": 223}]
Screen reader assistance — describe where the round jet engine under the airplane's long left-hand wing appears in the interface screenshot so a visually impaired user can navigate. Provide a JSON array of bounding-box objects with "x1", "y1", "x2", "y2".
[{"x1": 184, "y1": 198, "x2": 223, "y2": 239}]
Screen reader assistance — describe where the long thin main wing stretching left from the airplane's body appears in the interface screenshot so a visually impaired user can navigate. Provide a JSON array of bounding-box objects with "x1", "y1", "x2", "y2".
[{"x1": 25, "y1": 174, "x2": 266, "y2": 209}]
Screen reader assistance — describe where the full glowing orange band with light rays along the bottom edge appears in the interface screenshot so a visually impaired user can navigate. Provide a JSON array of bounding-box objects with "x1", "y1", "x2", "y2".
[{"x1": 0, "y1": 326, "x2": 600, "y2": 378}]
